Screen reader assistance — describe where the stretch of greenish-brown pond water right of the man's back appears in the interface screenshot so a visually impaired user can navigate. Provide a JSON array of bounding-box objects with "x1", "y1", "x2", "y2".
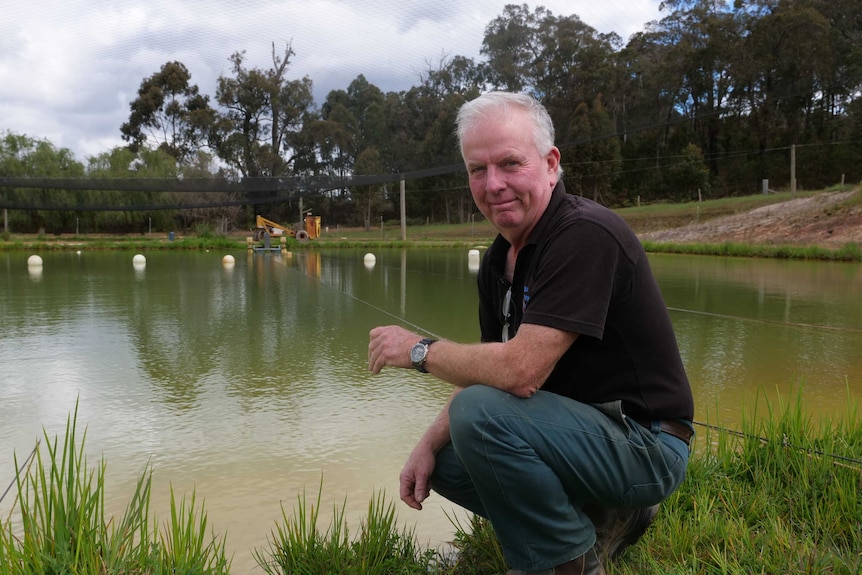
[{"x1": 650, "y1": 255, "x2": 862, "y2": 422}]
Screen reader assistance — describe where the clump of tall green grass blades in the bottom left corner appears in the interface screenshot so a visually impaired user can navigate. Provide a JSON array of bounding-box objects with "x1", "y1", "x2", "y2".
[{"x1": 0, "y1": 405, "x2": 230, "y2": 575}]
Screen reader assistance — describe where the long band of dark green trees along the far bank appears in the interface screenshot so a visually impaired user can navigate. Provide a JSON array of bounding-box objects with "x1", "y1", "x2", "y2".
[{"x1": 5, "y1": 0, "x2": 862, "y2": 233}]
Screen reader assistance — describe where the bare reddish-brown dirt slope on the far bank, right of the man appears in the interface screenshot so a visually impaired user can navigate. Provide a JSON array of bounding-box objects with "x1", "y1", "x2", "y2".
[{"x1": 640, "y1": 189, "x2": 862, "y2": 248}]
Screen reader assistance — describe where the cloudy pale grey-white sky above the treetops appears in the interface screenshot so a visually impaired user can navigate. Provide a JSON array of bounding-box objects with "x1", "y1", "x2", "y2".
[{"x1": 0, "y1": 0, "x2": 660, "y2": 163}]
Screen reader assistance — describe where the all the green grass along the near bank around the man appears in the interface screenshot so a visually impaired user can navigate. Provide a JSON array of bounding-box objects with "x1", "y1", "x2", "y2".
[{"x1": 0, "y1": 395, "x2": 862, "y2": 575}]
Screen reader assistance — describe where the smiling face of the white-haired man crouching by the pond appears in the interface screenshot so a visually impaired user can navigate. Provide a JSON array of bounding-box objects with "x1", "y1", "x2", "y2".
[{"x1": 461, "y1": 111, "x2": 560, "y2": 242}]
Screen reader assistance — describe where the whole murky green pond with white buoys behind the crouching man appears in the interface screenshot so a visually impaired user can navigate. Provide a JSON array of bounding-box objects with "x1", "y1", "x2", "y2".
[{"x1": 0, "y1": 249, "x2": 862, "y2": 574}]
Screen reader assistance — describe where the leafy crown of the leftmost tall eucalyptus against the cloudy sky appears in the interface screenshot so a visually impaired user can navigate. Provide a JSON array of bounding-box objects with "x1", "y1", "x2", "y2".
[{"x1": 120, "y1": 61, "x2": 215, "y2": 164}]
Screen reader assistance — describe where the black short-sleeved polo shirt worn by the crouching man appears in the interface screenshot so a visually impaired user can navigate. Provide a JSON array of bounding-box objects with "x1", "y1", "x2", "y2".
[{"x1": 478, "y1": 182, "x2": 694, "y2": 420}]
